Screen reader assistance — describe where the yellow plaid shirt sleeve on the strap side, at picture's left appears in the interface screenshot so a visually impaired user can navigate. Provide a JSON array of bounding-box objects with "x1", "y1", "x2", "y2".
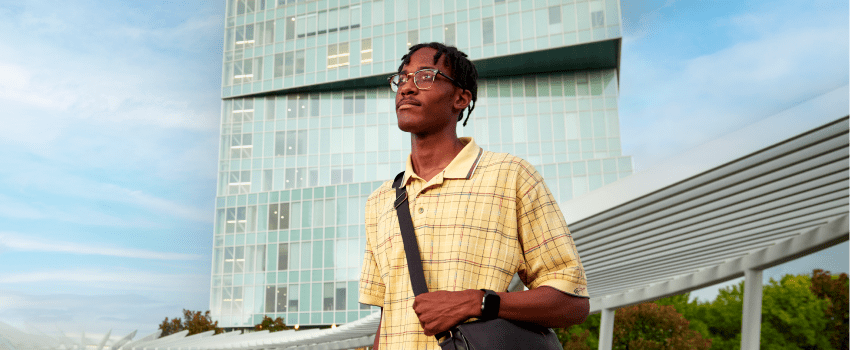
[{"x1": 359, "y1": 193, "x2": 386, "y2": 307}]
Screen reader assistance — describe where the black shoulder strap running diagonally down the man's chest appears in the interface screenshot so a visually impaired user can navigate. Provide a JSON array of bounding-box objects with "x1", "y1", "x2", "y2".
[{"x1": 393, "y1": 171, "x2": 428, "y2": 295}]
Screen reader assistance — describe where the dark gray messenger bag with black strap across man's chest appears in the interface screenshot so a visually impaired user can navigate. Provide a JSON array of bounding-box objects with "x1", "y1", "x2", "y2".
[{"x1": 393, "y1": 172, "x2": 563, "y2": 350}]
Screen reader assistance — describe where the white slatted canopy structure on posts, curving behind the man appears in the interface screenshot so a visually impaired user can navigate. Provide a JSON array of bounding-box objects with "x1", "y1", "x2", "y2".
[{"x1": 0, "y1": 86, "x2": 850, "y2": 350}]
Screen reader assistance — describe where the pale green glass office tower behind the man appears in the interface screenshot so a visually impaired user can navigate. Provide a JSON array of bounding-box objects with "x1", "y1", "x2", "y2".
[{"x1": 210, "y1": 0, "x2": 632, "y2": 328}]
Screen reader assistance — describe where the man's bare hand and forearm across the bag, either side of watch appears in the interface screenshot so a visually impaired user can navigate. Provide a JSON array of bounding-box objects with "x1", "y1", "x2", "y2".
[{"x1": 413, "y1": 286, "x2": 590, "y2": 336}]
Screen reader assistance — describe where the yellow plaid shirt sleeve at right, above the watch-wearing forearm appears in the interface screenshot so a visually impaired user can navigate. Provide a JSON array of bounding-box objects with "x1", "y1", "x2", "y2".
[{"x1": 517, "y1": 161, "x2": 589, "y2": 297}]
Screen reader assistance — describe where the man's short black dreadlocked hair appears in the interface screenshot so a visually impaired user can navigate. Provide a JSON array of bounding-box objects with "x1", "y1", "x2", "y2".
[{"x1": 398, "y1": 42, "x2": 478, "y2": 126}]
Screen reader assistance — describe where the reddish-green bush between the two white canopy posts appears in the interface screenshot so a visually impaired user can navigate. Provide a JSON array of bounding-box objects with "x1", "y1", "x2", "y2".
[{"x1": 613, "y1": 303, "x2": 711, "y2": 350}]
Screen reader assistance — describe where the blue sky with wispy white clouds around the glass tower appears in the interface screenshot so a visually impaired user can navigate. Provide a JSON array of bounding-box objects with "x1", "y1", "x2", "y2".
[{"x1": 0, "y1": 0, "x2": 850, "y2": 339}]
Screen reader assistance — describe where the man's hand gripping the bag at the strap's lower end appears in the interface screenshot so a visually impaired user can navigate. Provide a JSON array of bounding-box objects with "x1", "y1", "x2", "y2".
[{"x1": 413, "y1": 289, "x2": 484, "y2": 336}]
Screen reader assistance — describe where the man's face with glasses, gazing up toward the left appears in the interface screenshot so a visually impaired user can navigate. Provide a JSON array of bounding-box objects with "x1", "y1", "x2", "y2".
[{"x1": 395, "y1": 47, "x2": 469, "y2": 134}]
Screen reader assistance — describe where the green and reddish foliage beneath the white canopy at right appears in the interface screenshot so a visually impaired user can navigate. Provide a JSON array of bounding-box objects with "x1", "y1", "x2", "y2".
[{"x1": 556, "y1": 270, "x2": 850, "y2": 350}]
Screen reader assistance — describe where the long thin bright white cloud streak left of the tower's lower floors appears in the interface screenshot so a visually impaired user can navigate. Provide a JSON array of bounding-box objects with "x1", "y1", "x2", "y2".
[{"x1": 0, "y1": 232, "x2": 201, "y2": 260}]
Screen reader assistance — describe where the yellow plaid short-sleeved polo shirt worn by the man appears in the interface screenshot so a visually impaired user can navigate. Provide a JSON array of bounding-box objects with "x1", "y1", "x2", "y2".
[{"x1": 360, "y1": 137, "x2": 588, "y2": 350}]
